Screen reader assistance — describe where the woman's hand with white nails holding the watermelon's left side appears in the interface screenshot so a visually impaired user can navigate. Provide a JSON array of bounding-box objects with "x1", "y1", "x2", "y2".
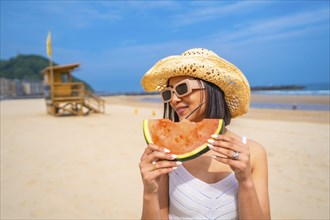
[{"x1": 139, "y1": 144, "x2": 182, "y2": 193}]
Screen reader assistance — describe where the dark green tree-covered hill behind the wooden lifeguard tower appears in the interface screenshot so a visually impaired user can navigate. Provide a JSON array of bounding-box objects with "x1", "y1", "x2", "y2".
[{"x1": 0, "y1": 55, "x2": 93, "y2": 91}]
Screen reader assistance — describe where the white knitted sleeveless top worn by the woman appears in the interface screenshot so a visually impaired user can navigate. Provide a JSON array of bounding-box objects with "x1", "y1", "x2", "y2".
[{"x1": 169, "y1": 137, "x2": 246, "y2": 219}]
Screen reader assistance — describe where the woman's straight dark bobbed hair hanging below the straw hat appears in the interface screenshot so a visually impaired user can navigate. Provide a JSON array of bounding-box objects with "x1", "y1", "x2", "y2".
[{"x1": 163, "y1": 80, "x2": 231, "y2": 125}]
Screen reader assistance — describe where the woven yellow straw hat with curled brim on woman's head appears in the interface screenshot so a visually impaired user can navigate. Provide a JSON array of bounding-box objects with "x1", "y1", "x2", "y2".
[{"x1": 141, "y1": 48, "x2": 250, "y2": 118}]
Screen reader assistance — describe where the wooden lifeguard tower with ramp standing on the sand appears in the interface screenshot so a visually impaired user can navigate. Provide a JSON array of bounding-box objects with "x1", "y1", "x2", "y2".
[{"x1": 42, "y1": 64, "x2": 105, "y2": 116}]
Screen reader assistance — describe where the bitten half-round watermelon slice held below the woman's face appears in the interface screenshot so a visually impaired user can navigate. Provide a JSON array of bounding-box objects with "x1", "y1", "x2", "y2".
[{"x1": 143, "y1": 119, "x2": 224, "y2": 161}]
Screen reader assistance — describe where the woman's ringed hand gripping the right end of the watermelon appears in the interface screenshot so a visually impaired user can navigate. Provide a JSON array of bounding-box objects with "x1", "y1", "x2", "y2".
[{"x1": 208, "y1": 135, "x2": 251, "y2": 182}]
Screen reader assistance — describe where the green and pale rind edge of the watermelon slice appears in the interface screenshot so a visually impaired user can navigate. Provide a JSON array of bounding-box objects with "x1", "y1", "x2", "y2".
[{"x1": 143, "y1": 119, "x2": 224, "y2": 162}]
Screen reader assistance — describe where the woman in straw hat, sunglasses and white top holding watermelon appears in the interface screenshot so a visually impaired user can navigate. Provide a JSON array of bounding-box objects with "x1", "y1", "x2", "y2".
[{"x1": 139, "y1": 48, "x2": 270, "y2": 219}]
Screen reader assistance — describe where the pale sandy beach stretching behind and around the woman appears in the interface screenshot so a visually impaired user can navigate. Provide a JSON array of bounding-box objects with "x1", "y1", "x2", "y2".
[{"x1": 0, "y1": 95, "x2": 330, "y2": 219}]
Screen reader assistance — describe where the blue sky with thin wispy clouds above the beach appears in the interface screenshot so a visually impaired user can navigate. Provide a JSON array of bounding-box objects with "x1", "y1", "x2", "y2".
[{"x1": 0, "y1": 0, "x2": 330, "y2": 92}]
